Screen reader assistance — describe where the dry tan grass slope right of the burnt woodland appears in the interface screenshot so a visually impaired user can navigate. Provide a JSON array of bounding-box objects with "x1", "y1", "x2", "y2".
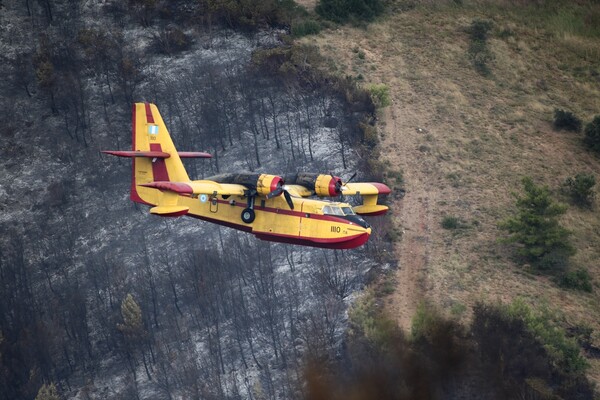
[{"x1": 305, "y1": 0, "x2": 600, "y2": 383}]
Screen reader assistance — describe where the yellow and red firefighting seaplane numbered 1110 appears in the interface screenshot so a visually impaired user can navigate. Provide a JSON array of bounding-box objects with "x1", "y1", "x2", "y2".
[{"x1": 103, "y1": 103, "x2": 390, "y2": 249}]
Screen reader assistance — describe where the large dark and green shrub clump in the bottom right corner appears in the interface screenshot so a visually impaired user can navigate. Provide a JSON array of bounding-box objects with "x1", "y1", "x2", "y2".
[{"x1": 471, "y1": 300, "x2": 593, "y2": 399}]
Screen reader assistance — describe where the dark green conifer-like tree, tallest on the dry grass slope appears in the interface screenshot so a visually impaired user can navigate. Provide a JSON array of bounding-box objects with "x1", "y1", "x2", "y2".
[{"x1": 499, "y1": 177, "x2": 575, "y2": 269}]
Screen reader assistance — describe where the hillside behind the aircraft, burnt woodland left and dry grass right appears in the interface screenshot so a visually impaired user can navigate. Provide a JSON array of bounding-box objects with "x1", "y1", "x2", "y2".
[{"x1": 0, "y1": 0, "x2": 600, "y2": 400}]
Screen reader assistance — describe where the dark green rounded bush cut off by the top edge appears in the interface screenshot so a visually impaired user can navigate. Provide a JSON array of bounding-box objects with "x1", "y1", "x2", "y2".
[{"x1": 315, "y1": 0, "x2": 384, "y2": 23}]
